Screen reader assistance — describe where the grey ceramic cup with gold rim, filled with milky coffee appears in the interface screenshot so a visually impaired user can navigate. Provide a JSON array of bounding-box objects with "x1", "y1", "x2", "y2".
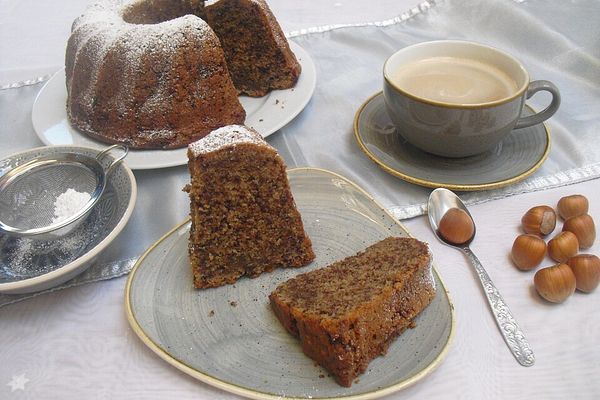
[{"x1": 383, "y1": 40, "x2": 560, "y2": 157}]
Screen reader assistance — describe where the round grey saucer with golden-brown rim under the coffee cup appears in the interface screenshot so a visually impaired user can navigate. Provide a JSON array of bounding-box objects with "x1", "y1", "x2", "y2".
[{"x1": 354, "y1": 92, "x2": 550, "y2": 191}]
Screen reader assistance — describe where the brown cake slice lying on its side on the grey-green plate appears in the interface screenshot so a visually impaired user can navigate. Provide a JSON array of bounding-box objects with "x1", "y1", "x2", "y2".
[{"x1": 269, "y1": 237, "x2": 435, "y2": 386}]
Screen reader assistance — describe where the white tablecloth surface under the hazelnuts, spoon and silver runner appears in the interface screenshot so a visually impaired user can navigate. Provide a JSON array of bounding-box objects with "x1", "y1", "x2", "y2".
[{"x1": 0, "y1": 0, "x2": 600, "y2": 399}]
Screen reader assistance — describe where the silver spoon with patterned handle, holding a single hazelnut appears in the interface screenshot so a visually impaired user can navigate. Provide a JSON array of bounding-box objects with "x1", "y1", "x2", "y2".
[{"x1": 427, "y1": 188, "x2": 535, "y2": 367}]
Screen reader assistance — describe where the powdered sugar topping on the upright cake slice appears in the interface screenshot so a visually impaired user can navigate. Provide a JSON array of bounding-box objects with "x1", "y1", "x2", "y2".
[{"x1": 189, "y1": 125, "x2": 271, "y2": 155}]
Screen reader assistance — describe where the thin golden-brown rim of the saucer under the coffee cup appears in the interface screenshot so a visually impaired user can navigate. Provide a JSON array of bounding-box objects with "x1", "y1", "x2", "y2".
[{"x1": 353, "y1": 91, "x2": 551, "y2": 192}]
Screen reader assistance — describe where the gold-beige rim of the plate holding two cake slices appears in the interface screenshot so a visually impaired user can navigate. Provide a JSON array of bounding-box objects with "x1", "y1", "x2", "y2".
[{"x1": 125, "y1": 167, "x2": 456, "y2": 400}]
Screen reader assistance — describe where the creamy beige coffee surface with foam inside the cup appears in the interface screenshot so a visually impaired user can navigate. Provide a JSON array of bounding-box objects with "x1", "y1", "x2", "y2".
[{"x1": 390, "y1": 57, "x2": 518, "y2": 104}]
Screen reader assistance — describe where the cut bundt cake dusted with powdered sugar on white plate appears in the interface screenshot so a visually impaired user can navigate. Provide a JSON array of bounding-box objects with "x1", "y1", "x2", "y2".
[{"x1": 65, "y1": 0, "x2": 300, "y2": 149}]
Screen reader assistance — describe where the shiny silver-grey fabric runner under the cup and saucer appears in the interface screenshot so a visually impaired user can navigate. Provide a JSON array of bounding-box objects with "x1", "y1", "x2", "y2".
[{"x1": 0, "y1": 0, "x2": 600, "y2": 306}]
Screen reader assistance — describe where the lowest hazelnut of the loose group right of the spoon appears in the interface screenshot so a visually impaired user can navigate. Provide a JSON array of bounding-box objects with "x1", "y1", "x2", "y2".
[{"x1": 533, "y1": 264, "x2": 575, "y2": 303}]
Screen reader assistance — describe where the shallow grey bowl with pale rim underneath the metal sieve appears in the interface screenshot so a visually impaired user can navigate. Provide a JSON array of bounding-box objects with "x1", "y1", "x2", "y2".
[{"x1": 0, "y1": 146, "x2": 137, "y2": 294}]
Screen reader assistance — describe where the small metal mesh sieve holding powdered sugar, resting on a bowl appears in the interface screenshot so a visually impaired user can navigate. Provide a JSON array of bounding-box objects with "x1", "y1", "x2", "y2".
[{"x1": 0, "y1": 144, "x2": 128, "y2": 239}]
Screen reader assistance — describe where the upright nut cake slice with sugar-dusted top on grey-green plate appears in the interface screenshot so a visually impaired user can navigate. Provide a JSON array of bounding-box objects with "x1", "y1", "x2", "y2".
[{"x1": 185, "y1": 125, "x2": 315, "y2": 288}]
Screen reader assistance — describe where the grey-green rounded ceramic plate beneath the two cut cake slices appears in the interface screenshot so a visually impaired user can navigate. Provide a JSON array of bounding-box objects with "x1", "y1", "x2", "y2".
[{"x1": 126, "y1": 168, "x2": 454, "y2": 399}]
